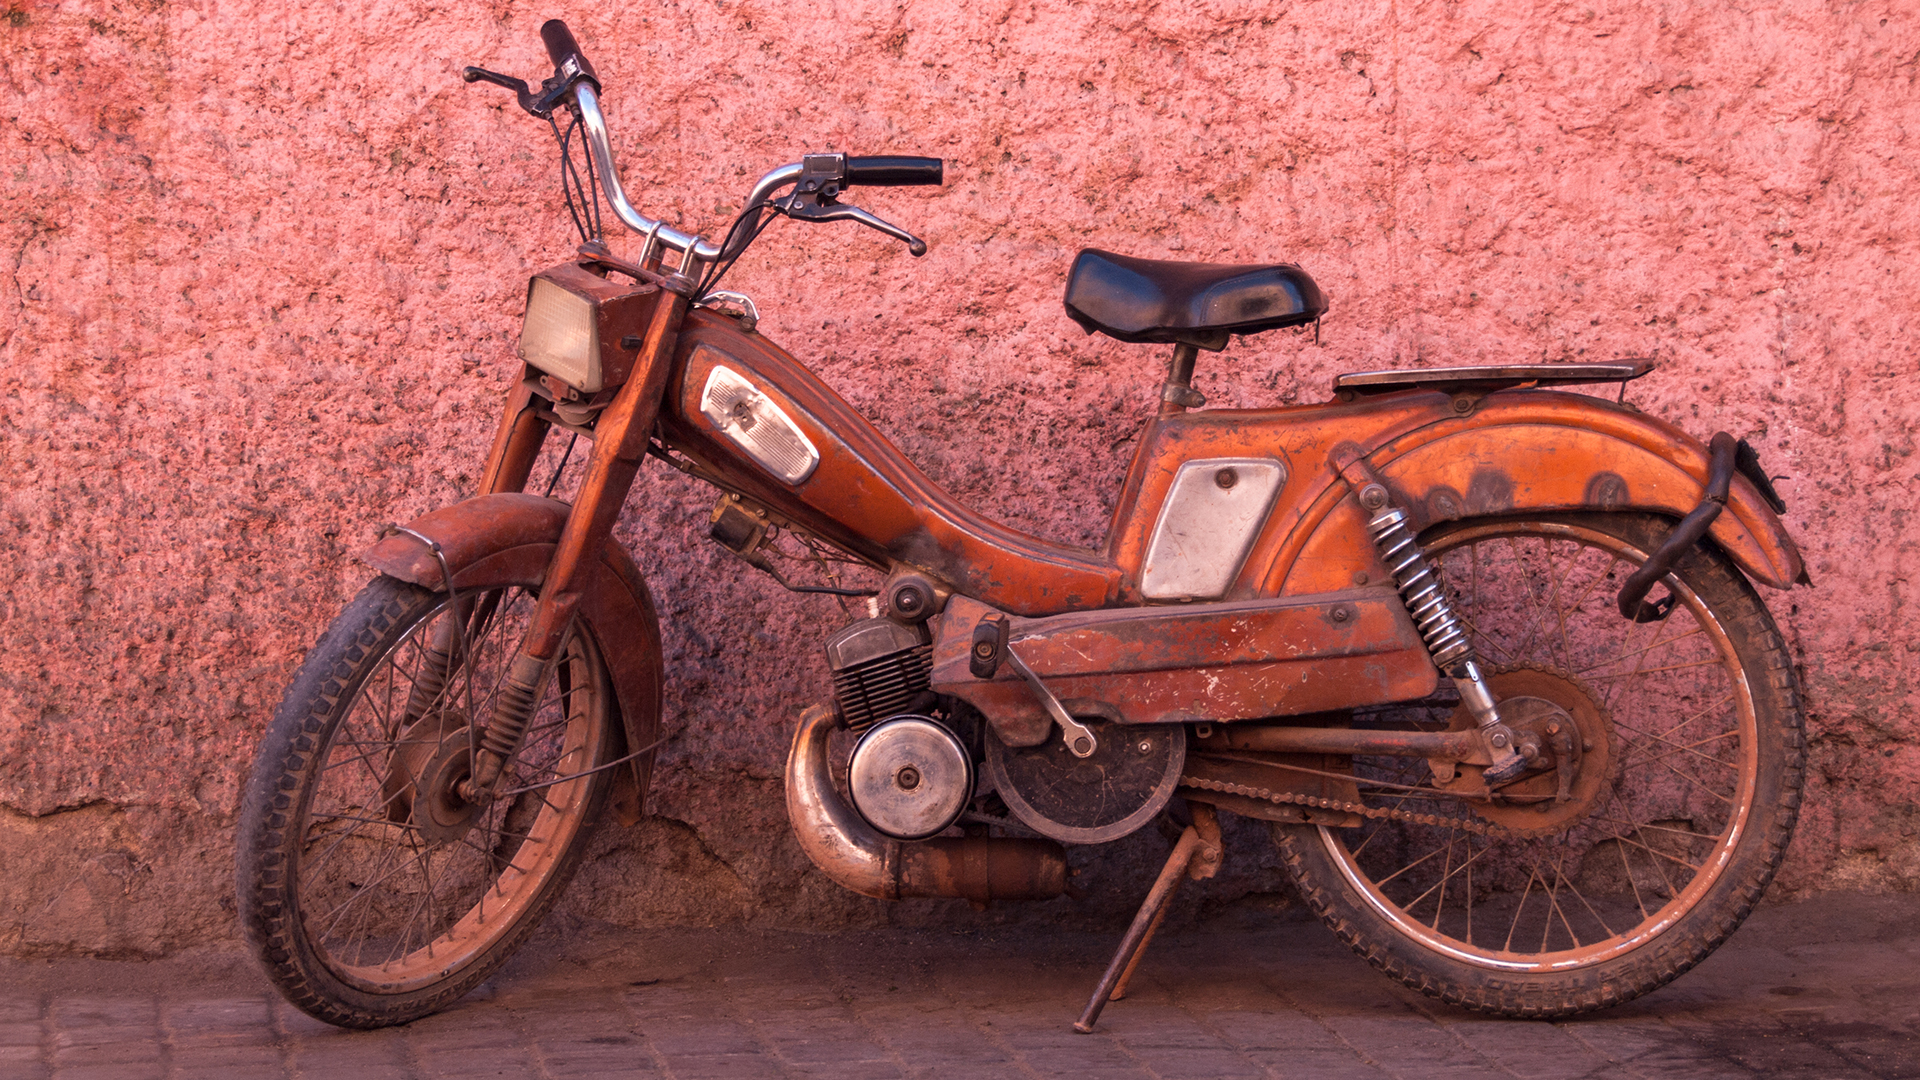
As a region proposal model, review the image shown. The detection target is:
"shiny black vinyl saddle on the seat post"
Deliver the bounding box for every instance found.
[1066,248,1327,350]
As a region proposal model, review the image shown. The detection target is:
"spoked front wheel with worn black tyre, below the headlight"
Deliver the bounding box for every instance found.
[236,577,620,1028]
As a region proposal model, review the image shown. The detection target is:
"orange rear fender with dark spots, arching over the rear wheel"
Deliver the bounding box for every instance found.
[1269,390,1807,592]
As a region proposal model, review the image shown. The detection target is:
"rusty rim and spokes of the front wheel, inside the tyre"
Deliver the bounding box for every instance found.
[290,588,609,994]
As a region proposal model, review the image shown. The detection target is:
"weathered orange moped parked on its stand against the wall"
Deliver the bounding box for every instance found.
[236,21,1811,1030]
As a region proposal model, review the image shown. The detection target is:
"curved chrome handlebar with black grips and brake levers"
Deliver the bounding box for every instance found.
[476,19,945,273]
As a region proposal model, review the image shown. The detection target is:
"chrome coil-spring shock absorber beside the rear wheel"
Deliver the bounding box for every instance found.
[1359,482,1526,784]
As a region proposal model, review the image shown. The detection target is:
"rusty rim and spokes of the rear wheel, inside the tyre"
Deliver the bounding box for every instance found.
[1319,521,1759,972]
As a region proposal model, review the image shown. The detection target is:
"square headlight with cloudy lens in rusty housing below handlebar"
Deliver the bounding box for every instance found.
[520,263,660,394]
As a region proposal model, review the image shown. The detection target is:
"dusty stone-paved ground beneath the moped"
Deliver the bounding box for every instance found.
[0,896,1920,1080]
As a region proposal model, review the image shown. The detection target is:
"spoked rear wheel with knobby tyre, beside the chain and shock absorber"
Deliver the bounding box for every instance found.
[1277,515,1805,1017]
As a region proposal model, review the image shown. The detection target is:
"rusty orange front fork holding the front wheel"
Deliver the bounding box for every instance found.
[432,290,687,801]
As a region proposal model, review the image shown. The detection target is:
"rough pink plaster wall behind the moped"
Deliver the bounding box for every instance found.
[0,0,1920,953]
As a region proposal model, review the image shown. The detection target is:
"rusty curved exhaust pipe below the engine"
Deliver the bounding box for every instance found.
[787,705,1068,903]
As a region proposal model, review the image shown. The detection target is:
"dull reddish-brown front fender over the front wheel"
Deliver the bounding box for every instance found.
[361,492,664,811]
